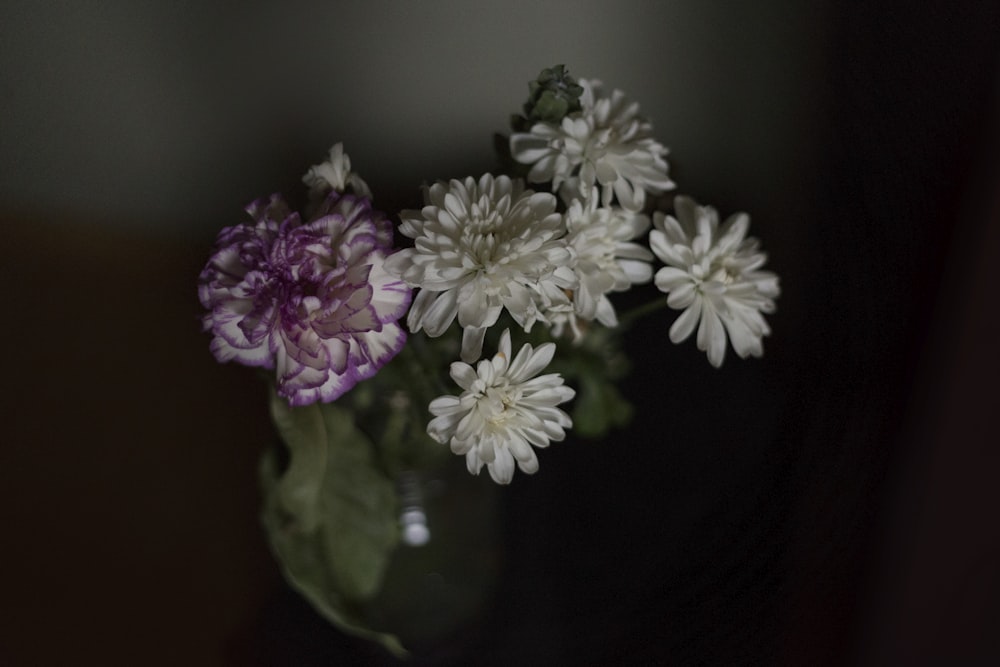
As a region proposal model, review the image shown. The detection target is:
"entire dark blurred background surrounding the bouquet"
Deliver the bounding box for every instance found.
[0,0,1000,665]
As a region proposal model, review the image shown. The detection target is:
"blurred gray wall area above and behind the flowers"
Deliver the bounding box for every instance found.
[0,0,825,237]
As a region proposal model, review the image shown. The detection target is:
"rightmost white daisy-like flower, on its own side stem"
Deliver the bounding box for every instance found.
[649,197,781,367]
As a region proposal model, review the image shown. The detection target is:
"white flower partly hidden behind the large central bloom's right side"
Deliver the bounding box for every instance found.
[565,190,653,331]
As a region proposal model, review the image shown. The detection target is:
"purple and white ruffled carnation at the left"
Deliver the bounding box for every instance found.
[198,193,410,405]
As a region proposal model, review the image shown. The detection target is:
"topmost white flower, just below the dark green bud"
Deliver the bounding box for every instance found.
[510,79,674,211]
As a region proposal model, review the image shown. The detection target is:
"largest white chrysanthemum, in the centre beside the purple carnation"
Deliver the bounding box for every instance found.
[385,174,576,363]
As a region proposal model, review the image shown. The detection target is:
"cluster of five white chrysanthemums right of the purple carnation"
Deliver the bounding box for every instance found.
[385,69,779,483]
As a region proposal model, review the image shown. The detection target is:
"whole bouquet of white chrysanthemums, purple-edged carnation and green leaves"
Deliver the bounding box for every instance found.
[199,66,779,654]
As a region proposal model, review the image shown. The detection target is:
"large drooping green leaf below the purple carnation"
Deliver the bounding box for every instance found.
[261,395,405,655]
